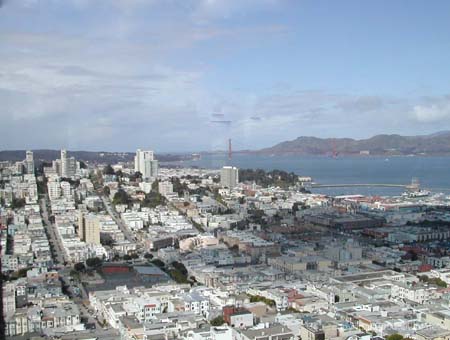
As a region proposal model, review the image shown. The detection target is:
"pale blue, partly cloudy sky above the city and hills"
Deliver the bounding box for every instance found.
[0,0,450,152]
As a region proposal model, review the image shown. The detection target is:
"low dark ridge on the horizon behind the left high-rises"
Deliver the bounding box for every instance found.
[0,150,191,164]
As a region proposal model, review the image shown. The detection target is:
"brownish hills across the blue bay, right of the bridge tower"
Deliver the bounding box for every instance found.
[256,131,450,155]
